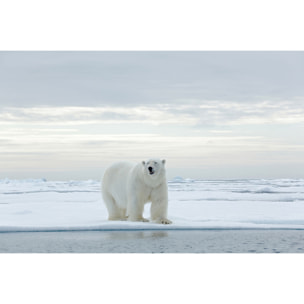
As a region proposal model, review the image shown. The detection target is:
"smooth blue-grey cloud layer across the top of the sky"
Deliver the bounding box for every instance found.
[0,52,304,107]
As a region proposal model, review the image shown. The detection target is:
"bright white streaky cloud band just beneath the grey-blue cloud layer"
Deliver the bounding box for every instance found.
[0,101,304,128]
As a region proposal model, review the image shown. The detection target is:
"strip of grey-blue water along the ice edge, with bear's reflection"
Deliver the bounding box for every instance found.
[0,230,304,253]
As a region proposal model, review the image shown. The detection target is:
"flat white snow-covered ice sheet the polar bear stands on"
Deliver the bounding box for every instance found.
[0,177,304,232]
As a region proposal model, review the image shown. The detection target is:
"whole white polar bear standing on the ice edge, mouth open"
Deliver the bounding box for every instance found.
[101,158,172,224]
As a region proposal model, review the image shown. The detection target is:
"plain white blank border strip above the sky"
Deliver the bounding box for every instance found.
[0,0,304,50]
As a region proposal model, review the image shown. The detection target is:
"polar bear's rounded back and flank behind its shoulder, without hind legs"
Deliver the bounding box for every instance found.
[102,162,136,208]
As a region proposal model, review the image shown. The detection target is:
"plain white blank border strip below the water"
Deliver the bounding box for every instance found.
[0,254,304,304]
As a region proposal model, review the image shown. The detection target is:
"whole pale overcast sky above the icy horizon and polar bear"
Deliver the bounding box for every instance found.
[0,51,304,180]
